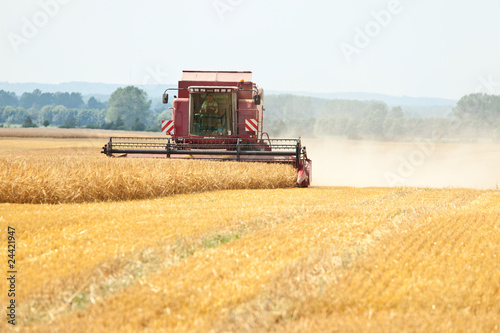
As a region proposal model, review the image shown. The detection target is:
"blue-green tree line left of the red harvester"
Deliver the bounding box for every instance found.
[0,86,171,131]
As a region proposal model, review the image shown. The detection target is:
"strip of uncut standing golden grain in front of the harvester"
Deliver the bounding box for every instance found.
[0,153,296,203]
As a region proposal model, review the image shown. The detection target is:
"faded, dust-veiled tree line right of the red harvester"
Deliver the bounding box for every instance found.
[264,93,500,141]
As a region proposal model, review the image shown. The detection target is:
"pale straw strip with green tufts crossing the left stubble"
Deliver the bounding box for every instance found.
[15,205,301,325]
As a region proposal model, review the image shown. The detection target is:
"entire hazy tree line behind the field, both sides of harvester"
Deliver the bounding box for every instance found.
[0,86,500,140]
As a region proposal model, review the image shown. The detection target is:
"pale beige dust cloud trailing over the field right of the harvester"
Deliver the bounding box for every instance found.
[302,138,500,189]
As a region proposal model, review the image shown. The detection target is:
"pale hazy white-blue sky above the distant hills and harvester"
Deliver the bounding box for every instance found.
[0,0,500,99]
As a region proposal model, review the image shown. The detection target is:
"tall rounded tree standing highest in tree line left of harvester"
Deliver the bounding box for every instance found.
[106,86,151,128]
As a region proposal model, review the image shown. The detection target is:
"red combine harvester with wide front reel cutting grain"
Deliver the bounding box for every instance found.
[102,71,312,187]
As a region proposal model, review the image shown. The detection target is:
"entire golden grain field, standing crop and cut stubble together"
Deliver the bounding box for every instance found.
[0,128,500,332]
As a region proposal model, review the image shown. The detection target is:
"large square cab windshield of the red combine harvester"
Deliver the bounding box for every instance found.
[190,93,232,136]
